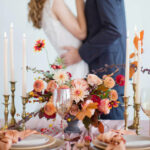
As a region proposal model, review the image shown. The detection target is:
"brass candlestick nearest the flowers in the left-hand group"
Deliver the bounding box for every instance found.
[22,97,27,130]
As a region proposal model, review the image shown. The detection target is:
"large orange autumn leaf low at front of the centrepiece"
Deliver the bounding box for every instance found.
[76,103,98,120]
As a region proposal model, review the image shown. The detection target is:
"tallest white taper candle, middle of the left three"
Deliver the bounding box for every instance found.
[10,23,15,82]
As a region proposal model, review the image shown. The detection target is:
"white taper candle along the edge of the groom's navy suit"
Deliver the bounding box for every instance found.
[124,32,130,97]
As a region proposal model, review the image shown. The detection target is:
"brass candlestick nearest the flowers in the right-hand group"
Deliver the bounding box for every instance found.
[123,97,129,130]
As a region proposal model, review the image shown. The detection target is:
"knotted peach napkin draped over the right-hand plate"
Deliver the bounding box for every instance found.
[98,130,135,150]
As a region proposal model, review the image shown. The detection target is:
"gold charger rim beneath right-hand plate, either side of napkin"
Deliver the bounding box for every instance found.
[92,140,150,150]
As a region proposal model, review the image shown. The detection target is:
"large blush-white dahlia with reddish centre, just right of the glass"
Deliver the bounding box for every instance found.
[71,85,89,103]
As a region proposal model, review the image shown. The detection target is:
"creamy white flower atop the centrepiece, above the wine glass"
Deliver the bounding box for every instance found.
[54,70,69,85]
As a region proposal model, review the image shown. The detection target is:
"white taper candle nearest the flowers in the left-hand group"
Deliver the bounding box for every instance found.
[22,34,27,97]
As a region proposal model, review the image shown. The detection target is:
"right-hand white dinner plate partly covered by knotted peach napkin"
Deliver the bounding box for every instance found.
[93,135,150,150]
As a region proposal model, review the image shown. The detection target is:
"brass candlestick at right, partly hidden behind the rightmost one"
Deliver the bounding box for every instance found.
[128,83,136,129]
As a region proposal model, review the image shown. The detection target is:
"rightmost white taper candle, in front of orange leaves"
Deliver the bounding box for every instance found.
[136,40,141,104]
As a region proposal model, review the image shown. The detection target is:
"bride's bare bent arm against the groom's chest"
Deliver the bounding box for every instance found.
[52,0,87,40]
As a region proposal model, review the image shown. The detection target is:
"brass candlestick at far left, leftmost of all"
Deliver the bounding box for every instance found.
[4,95,9,130]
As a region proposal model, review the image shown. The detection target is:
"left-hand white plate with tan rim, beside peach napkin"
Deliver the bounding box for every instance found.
[11,134,56,150]
